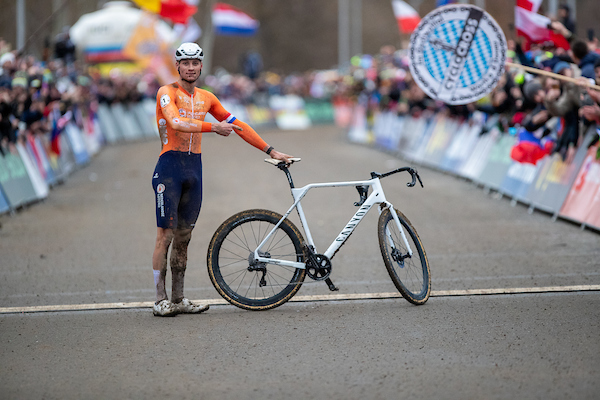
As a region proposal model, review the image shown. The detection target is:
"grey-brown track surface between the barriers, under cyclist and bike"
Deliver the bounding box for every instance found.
[0,127,600,399]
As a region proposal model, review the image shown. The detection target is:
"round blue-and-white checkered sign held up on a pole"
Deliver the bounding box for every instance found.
[409,4,506,105]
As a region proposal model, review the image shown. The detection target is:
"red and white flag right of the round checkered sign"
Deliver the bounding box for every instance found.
[515,0,569,50]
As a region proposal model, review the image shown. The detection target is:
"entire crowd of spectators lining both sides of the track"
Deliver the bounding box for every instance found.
[0,10,600,166]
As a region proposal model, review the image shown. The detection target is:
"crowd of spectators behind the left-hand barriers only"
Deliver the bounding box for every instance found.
[0,37,158,154]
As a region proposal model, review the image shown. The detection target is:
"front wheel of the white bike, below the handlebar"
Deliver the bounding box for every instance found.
[377,209,431,305]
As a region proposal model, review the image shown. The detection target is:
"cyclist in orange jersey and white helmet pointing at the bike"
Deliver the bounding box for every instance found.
[152,43,292,316]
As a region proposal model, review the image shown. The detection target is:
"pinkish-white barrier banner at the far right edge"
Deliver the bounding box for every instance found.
[560,146,600,229]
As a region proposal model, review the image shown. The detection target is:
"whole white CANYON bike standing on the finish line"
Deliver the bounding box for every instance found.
[207,158,431,310]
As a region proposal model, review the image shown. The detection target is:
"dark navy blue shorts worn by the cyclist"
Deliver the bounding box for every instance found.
[152,151,202,229]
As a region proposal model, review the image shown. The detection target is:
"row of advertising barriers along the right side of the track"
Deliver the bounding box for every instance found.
[348,104,600,233]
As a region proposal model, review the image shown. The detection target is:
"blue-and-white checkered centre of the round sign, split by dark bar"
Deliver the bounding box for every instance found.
[423,19,492,87]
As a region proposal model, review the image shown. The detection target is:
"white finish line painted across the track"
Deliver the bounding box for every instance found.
[0,285,600,314]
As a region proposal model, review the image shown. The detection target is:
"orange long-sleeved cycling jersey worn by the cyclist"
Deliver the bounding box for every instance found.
[156,82,267,155]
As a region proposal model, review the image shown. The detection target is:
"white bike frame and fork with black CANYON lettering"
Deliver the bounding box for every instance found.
[254,177,412,269]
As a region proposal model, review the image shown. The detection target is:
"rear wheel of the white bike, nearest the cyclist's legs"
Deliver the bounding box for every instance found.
[207,210,306,310]
